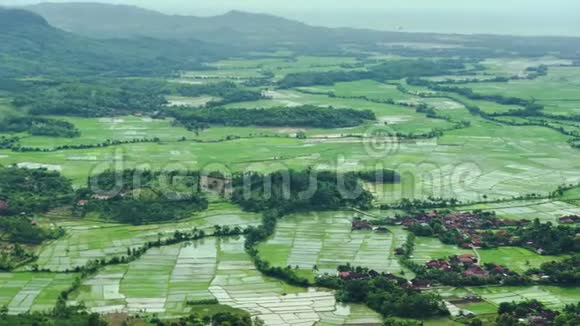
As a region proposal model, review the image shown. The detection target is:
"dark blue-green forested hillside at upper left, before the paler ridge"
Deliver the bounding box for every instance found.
[0,8,230,79]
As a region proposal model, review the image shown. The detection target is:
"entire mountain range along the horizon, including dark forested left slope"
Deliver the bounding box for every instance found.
[0,3,580,78]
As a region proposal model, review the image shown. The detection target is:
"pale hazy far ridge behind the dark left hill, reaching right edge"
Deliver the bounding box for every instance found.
[23,3,580,56]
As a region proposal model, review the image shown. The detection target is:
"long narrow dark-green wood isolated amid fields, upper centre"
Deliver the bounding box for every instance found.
[170,105,376,130]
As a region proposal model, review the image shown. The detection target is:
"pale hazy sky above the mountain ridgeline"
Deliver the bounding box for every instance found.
[0,0,580,36]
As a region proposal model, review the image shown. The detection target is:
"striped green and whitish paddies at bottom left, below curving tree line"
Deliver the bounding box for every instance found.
[72,238,377,325]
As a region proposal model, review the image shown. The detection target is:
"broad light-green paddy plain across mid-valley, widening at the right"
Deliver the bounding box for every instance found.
[0,116,580,201]
